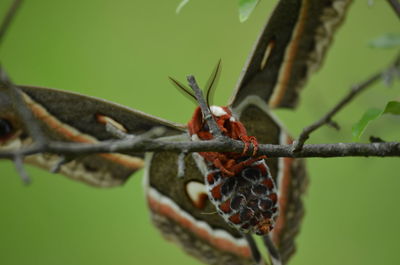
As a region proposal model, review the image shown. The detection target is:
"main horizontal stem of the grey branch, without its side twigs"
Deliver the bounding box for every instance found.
[0,139,400,159]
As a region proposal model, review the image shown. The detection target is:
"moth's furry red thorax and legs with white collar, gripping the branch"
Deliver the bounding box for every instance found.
[188,106,266,176]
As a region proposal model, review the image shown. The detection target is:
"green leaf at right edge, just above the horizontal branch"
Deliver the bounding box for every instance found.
[352,101,400,140]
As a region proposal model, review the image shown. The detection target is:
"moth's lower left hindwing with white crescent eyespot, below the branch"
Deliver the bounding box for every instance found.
[144,136,260,265]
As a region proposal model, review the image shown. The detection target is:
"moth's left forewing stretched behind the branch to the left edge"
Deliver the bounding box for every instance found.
[0,86,184,187]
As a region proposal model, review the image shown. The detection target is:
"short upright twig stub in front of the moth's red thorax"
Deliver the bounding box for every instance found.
[187,75,224,139]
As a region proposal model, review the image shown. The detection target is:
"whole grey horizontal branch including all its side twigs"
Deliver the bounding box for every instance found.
[0,62,400,182]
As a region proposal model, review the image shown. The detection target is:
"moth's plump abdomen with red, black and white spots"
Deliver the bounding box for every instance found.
[206,159,278,235]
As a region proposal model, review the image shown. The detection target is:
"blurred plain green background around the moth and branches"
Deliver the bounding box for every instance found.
[0,0,400,265]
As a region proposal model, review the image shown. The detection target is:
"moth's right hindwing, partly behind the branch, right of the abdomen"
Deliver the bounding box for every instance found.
[233,96,308,264]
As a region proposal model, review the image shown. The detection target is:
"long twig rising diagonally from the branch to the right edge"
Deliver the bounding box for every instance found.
[293,56,400,152]
